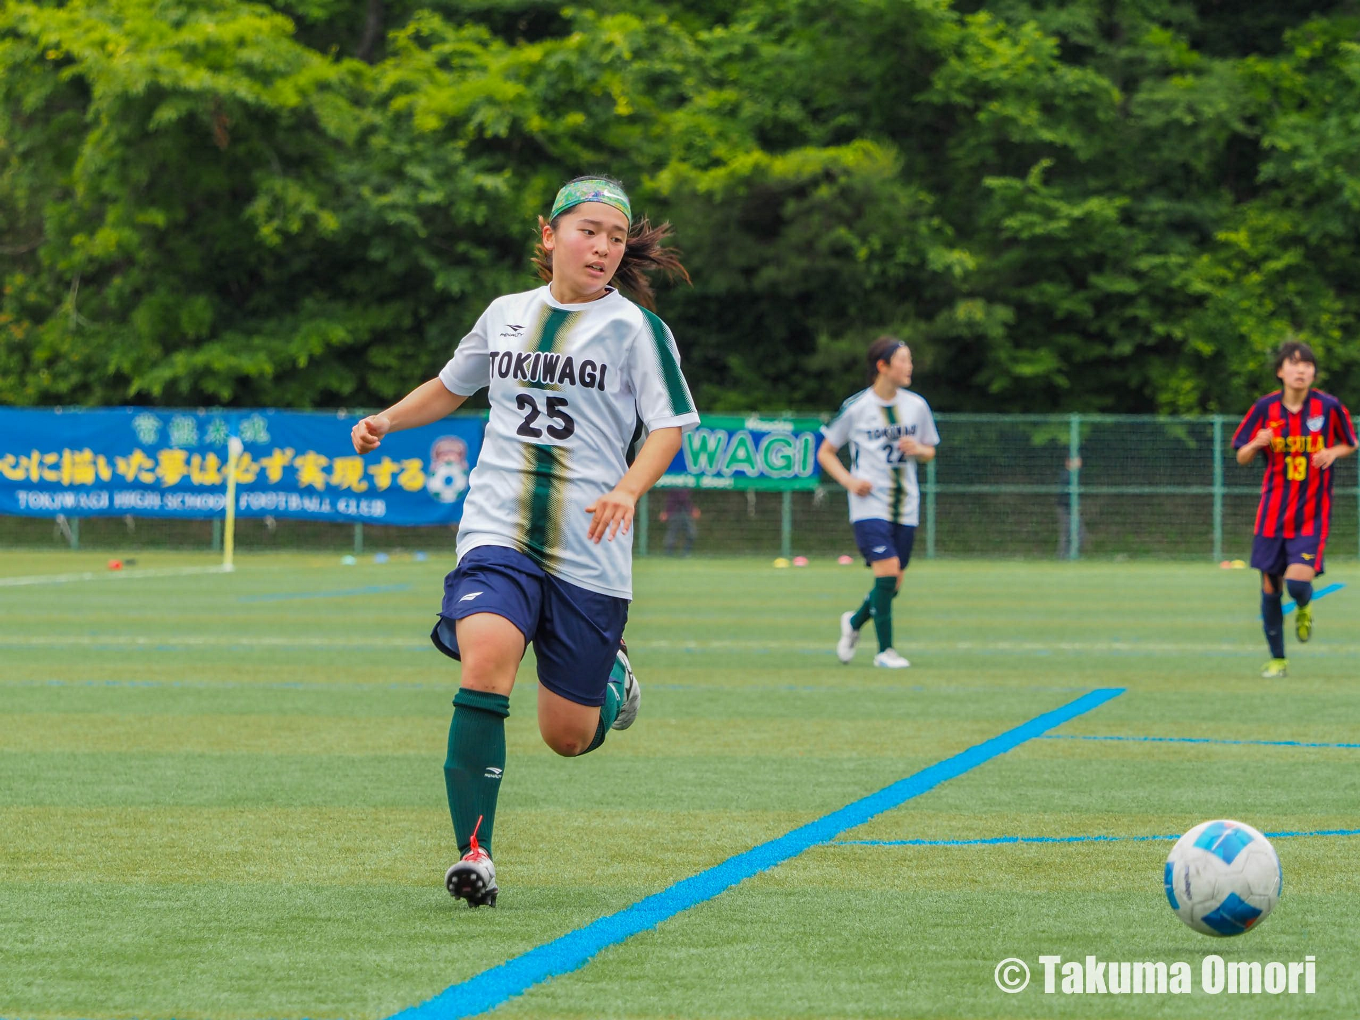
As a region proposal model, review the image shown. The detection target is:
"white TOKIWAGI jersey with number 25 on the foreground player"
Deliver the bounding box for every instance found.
[439,287,699,598]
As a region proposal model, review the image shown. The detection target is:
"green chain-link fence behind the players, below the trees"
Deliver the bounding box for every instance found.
[0,415,1360,560]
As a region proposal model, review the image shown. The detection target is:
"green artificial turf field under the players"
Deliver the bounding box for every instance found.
[0,551,1360,1020]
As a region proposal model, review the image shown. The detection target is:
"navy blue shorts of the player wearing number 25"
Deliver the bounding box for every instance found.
[430,545,628,706]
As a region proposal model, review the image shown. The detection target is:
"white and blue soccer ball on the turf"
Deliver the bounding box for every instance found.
[1164,819,1284,936]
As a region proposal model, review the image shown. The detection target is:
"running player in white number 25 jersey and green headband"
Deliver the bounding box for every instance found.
[352,177,699,907]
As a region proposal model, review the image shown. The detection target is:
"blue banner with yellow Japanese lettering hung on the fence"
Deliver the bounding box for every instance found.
[0,407,486,525]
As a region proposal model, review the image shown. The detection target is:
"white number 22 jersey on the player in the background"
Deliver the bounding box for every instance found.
[821,386,940,525]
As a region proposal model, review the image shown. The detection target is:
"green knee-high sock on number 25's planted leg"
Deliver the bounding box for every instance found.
[443,687,510,854]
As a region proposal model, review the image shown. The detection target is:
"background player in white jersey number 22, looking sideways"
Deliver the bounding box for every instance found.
[817,336,940,669]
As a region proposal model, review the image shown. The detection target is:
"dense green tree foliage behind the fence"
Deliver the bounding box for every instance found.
[0,0,1360,412]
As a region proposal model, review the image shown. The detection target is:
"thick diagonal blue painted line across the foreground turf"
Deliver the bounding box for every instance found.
[389,688,1123,1020]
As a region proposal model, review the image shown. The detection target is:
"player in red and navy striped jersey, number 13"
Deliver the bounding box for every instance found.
[1232,341,1357,677]
